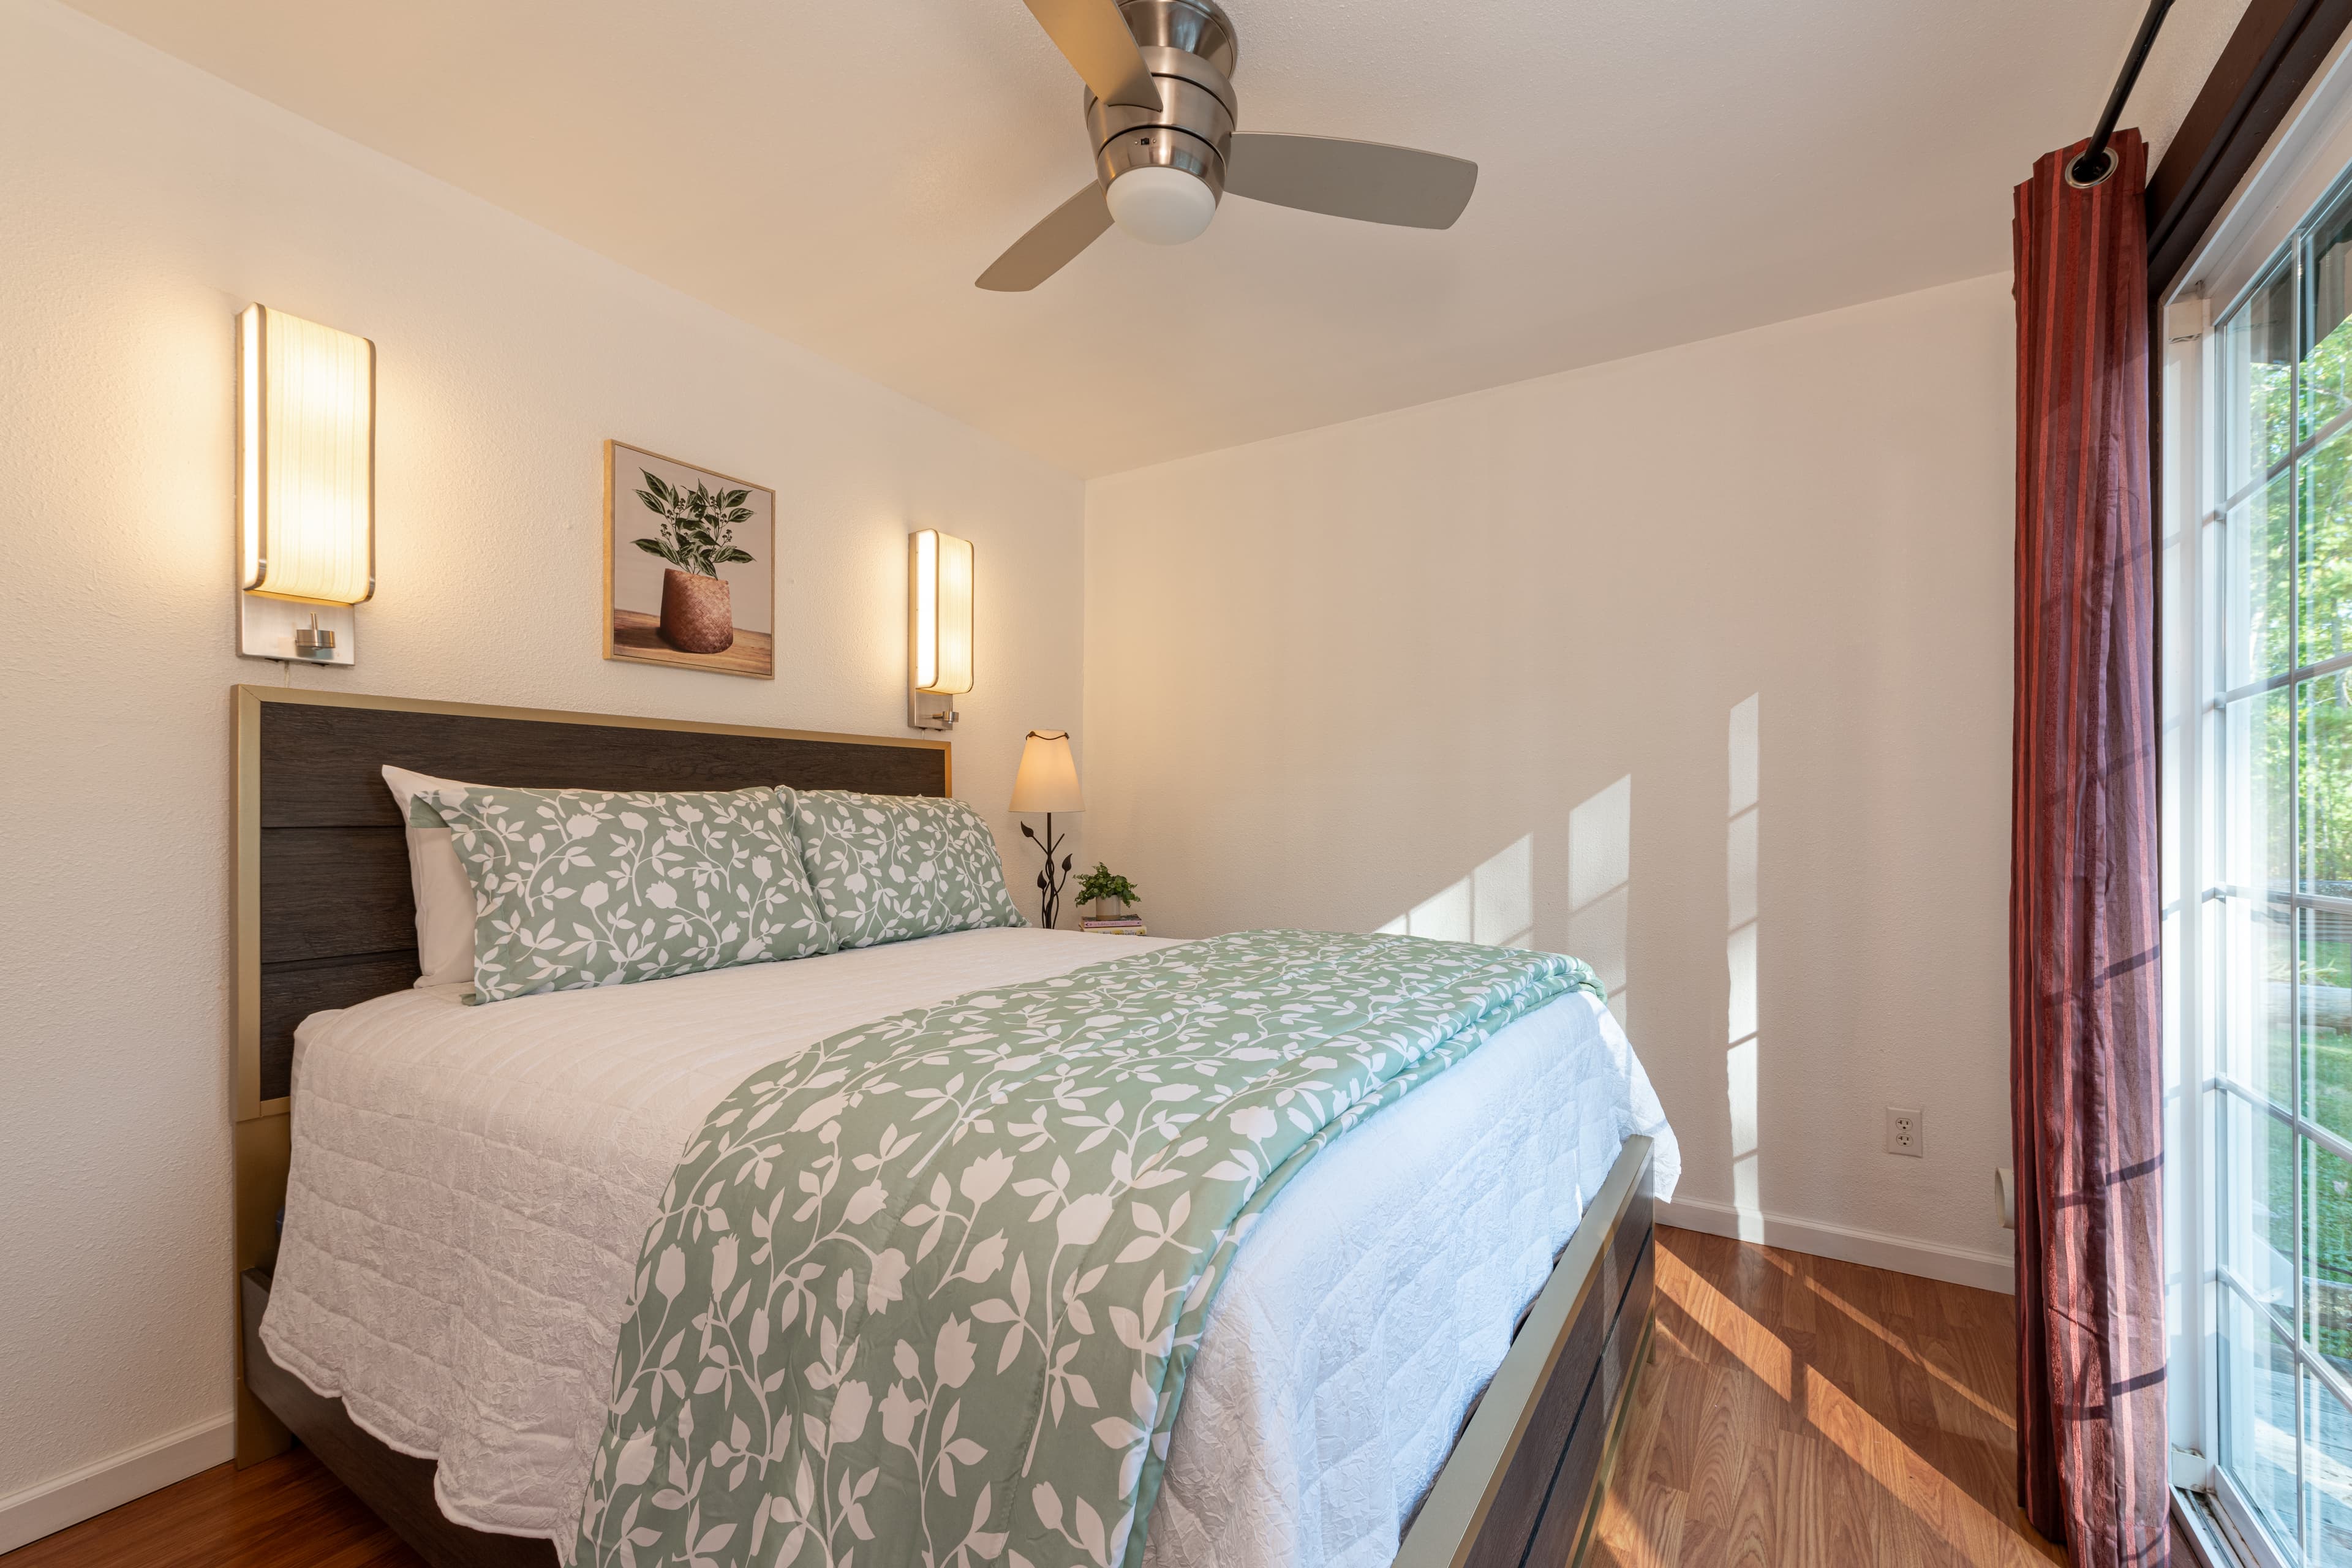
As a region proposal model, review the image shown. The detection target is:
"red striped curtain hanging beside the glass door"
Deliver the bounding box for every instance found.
[2008,132,2171,1568]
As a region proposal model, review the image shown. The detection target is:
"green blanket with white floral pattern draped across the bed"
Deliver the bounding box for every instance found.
[574,931,1602,1568]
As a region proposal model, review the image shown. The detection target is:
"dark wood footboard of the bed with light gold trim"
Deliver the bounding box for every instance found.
[1395,1138,1656,1568]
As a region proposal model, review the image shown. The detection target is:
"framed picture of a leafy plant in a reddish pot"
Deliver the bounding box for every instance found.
[605,442,776,679]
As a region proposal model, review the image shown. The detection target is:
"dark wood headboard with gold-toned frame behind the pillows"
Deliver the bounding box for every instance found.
[233,687,952,1458]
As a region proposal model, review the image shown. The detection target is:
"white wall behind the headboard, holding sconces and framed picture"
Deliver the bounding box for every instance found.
[0,0,1084,1547]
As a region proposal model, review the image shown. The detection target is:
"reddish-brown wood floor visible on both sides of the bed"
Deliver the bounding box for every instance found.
[13,1227,2079,1568]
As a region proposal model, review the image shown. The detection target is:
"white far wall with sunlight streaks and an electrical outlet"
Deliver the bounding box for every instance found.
[1087,277,2013,1286]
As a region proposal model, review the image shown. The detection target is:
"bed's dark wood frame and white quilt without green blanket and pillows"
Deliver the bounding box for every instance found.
[224,689,1677,1568]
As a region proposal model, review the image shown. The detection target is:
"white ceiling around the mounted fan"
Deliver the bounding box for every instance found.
[78,0,2244,475]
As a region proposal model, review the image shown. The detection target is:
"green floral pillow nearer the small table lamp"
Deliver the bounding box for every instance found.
[778,790,1028,948]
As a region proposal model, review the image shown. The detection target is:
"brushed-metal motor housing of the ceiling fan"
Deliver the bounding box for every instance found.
[1087,0,1240,200]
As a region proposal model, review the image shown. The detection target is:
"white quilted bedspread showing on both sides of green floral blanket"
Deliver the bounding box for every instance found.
[261,931,1679,1568]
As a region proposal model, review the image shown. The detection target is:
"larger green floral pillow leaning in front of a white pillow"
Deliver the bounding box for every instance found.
[417,785,835,1001]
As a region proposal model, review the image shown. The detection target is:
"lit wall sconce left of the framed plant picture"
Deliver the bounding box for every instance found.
[238,306,376,665]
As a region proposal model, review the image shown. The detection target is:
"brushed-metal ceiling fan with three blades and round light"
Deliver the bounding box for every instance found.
[978,0,1477,294]
